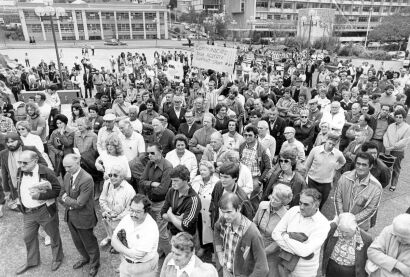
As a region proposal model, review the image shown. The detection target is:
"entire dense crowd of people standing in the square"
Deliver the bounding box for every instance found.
[0,45,410,277]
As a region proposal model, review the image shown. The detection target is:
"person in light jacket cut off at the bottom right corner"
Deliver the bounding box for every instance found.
[366,214,410,277]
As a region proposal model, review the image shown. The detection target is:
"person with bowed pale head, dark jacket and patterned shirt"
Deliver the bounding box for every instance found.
[322,213,372,277]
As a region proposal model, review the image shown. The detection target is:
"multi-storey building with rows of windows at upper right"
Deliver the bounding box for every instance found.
[225,0,410,41]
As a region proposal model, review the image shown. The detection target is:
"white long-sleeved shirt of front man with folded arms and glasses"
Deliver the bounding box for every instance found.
[272,206,330,277]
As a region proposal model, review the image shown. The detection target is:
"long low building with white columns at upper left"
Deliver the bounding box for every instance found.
[17,2,169,41]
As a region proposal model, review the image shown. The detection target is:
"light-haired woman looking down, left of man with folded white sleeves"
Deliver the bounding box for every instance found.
[253,184,293,277]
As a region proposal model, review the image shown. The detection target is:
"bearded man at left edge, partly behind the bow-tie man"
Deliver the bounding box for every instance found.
[0,132,47,217]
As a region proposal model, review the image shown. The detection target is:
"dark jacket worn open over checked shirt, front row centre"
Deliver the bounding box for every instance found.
[214,217,269,277]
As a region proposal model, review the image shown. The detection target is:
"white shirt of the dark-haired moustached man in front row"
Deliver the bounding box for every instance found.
[113,214,159,263]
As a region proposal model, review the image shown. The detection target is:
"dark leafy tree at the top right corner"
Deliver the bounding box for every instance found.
[369,9,410,42]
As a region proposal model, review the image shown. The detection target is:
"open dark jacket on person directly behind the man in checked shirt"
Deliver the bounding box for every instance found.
[209,181,256,229]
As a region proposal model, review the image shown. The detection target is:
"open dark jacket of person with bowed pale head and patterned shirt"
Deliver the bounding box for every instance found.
[322,223,373,277]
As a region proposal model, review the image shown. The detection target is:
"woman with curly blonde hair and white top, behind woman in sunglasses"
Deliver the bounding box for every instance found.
[95,134,131,179]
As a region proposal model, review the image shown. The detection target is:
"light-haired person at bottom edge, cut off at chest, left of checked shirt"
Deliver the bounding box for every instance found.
[160,232,218,277]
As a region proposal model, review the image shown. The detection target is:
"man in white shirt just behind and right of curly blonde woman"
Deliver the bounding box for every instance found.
[118,118,145,161]
